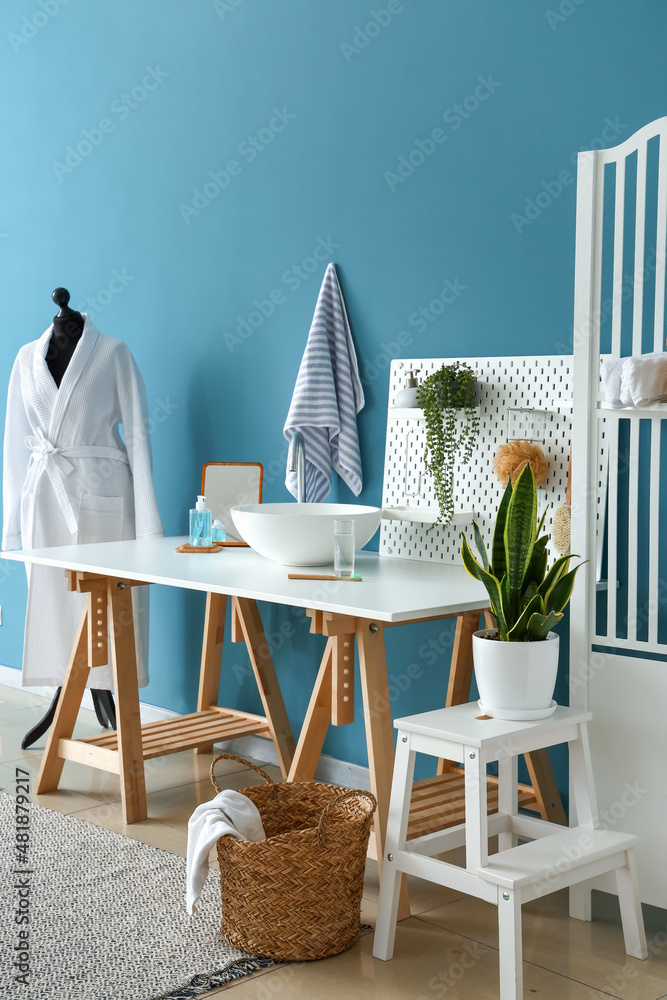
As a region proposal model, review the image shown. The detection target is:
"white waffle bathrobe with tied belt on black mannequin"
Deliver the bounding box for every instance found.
[2,313,163,689]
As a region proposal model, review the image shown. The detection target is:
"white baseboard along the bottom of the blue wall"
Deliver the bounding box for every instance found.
[0,664,371,791]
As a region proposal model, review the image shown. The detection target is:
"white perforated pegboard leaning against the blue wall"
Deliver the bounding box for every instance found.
[380,355,572,563]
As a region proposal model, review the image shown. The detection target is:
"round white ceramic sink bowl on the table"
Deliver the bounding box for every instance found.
[231,502,382,566]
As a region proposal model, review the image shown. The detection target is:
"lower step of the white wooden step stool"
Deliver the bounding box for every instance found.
[477,826,638,891]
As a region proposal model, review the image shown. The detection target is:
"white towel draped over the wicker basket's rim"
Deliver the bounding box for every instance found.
[185,788,266,913]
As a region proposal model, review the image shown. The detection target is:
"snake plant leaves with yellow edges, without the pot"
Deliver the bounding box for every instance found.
[461,465,581,642]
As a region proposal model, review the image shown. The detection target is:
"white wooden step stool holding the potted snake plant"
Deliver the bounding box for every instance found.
[373,702,648,1000]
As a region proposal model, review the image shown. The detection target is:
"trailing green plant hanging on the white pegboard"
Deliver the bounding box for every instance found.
[417,361,479,530]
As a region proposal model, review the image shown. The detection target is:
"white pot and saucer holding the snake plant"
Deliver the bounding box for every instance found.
[472,629,558,722]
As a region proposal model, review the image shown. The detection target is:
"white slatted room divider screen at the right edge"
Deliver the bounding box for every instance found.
[570,118,667,907]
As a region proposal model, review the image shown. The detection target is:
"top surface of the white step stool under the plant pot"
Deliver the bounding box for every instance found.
[394,701,593,748]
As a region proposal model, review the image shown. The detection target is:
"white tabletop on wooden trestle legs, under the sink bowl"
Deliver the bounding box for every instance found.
[2,537,488,622]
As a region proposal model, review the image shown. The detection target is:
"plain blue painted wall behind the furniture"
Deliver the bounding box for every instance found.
[0,0,667,788]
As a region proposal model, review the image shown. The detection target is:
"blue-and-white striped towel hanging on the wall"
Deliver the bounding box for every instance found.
[283,264,364,503]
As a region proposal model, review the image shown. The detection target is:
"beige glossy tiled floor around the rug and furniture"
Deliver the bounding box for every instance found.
[0,687,667,1000]
